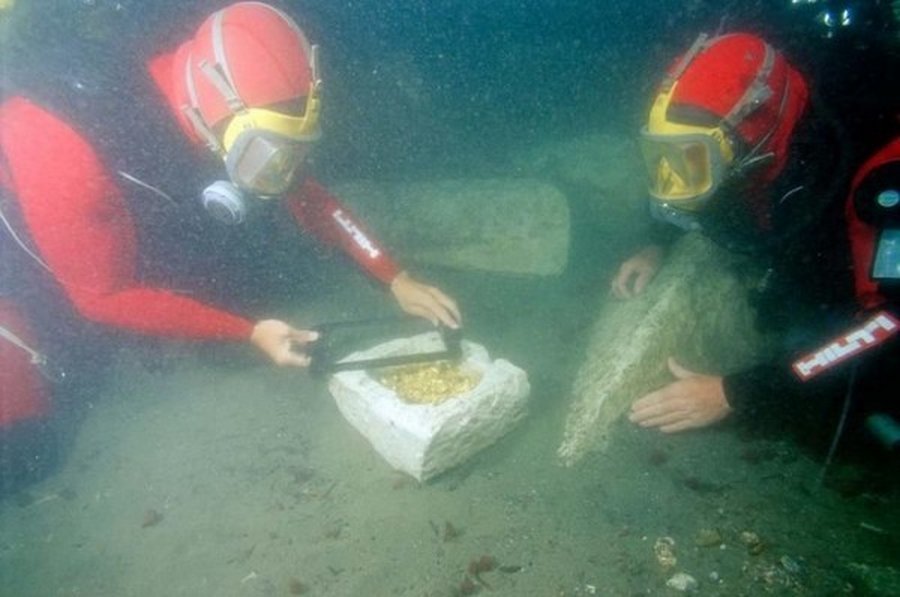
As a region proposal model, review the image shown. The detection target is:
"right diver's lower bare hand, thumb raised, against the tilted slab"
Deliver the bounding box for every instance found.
[628,357,731,433]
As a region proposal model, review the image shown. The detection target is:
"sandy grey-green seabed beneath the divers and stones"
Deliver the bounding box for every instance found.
[0,262,900,597]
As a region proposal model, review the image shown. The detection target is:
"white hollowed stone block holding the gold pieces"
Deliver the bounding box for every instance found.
[329,332,530,481]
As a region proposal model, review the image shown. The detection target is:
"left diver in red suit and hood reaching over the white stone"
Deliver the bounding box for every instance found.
[0,2,461,486]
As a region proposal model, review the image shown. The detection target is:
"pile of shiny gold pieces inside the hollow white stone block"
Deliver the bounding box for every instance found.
[375,361,481,404]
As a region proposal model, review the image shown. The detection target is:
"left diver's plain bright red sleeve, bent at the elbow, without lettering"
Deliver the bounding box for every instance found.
[0,97,253,340]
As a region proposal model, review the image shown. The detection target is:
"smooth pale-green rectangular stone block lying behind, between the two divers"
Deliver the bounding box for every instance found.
[334,179,569,276]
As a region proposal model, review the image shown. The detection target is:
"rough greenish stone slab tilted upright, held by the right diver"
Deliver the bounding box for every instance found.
[558,234,769,465]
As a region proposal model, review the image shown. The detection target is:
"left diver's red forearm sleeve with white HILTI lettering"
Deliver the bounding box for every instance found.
[287,177,400,284]
